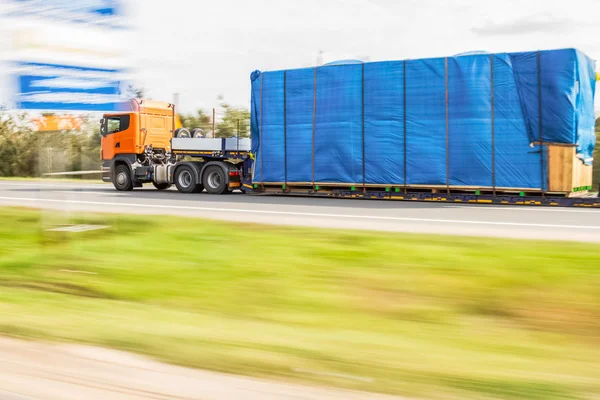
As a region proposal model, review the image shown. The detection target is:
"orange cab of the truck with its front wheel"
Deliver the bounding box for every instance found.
[100,99,181,190]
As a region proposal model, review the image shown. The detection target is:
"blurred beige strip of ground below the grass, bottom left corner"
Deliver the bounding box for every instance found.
[0,338,406,400]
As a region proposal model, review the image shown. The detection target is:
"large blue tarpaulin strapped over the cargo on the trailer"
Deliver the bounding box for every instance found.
[251,49,596,190]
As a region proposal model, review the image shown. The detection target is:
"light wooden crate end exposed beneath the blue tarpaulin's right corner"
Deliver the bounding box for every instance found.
[548,144,592,194]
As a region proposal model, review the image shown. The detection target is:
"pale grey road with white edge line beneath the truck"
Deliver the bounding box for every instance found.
[0,181,600,242]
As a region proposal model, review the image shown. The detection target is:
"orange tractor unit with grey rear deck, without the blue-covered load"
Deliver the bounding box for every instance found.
[100,99,251,194]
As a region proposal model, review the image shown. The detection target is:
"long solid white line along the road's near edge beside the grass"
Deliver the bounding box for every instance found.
[0,197,600,230]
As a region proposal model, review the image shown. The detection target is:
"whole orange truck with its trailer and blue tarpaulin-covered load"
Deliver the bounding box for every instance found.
[101,49,600,207]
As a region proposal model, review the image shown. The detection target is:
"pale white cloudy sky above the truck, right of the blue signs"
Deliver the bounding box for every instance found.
[129,0,600,112]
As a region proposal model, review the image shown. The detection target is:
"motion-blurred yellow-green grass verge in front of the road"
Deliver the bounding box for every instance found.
[0,208,600,400]
